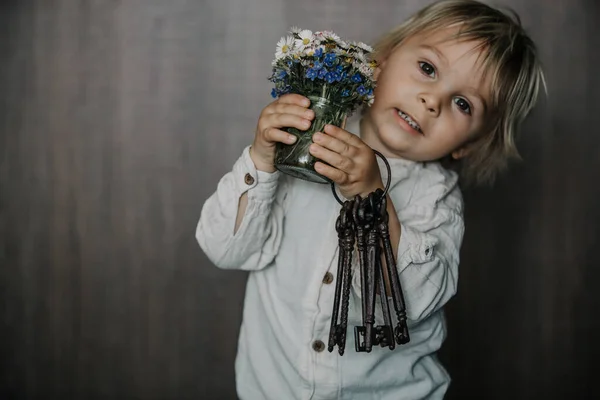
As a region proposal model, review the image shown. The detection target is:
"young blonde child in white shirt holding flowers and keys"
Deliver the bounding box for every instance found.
[196,0,544,400]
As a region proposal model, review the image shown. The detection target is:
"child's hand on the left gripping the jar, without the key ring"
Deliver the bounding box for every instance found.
[250,94,315,172]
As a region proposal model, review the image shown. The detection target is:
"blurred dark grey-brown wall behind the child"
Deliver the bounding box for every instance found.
[0,0,600,399]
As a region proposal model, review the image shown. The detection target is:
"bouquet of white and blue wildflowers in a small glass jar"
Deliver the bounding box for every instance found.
[269,28,376,183]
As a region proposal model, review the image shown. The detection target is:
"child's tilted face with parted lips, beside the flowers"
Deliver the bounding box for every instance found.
[361,28,490,161]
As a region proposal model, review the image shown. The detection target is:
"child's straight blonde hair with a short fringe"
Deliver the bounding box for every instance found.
[373,0,546,184]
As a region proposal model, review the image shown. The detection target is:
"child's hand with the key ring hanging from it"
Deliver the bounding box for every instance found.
[310,125,384,199]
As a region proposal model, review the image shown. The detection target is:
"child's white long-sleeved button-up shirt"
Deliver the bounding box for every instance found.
[196,119,464,400]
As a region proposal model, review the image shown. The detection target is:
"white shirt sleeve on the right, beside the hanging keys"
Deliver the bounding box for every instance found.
[353,175,464,325]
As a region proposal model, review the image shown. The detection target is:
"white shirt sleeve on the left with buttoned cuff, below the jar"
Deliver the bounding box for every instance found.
[196,147,284,270]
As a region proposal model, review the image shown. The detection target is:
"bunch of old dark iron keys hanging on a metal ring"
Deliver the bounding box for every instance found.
[328,150,410,355]
